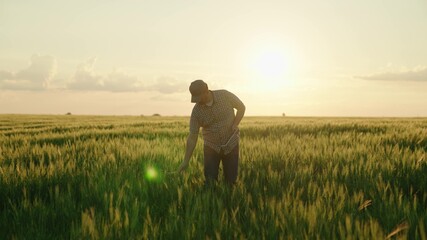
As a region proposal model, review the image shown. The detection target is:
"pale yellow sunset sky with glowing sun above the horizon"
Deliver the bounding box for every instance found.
[0,0,427,117]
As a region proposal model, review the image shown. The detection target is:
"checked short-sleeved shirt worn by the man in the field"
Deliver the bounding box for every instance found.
[190,90,245,154]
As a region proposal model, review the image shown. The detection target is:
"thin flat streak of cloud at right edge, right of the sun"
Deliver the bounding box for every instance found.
[355,67,427,82]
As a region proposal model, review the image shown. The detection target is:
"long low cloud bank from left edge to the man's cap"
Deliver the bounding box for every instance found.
[0,55,188,94]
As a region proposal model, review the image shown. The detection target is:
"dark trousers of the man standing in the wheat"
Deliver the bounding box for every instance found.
[203,145,239,184]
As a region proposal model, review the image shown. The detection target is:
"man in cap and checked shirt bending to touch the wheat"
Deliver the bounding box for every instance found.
[178,80,246,184]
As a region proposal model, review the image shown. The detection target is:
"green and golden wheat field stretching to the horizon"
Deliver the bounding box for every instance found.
[0,115,427,239]
